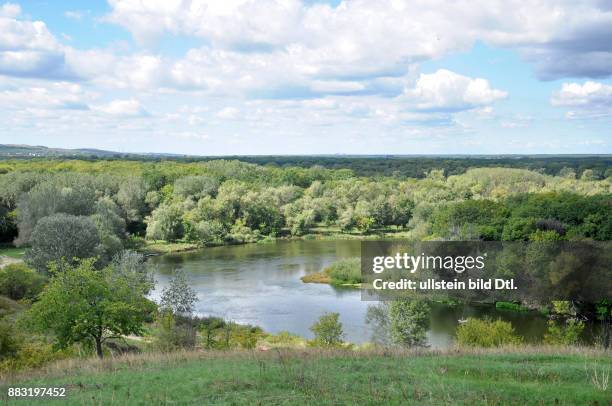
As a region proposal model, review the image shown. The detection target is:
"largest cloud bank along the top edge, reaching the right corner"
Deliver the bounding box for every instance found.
[107,0,612,79]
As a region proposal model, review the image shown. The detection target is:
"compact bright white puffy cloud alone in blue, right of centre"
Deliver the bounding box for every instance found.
[401,69,508,111]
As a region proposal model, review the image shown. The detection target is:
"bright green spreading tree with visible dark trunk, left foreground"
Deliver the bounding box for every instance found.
[28,259,155,358]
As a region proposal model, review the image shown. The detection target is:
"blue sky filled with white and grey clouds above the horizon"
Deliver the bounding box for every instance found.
[0,0,612,155]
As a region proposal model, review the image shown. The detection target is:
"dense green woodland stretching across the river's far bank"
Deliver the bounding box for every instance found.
[0,156,612,270]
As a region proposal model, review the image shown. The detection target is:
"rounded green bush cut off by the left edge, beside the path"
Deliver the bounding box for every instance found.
[0,264,46,300]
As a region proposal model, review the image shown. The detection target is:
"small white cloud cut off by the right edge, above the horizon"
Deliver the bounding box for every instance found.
[550,81,612,118]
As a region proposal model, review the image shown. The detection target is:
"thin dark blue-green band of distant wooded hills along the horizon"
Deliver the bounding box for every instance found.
[0,144,612,179]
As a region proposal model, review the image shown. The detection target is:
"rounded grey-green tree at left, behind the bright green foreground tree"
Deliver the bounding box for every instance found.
[25,214,100,271]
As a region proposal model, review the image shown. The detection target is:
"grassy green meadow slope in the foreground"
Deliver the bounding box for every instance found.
[0,347,612,405]
